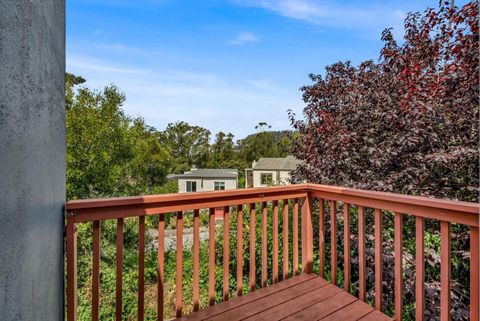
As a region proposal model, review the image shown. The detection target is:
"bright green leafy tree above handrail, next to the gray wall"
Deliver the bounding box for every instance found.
[65,74,172,199]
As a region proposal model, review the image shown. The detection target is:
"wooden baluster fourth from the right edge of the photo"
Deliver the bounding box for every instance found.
[394,213,403,320]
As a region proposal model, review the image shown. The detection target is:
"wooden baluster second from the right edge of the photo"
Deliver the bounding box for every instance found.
[440,221,452,321]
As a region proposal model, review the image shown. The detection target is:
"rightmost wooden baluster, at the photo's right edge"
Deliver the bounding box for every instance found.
[470,226,480,320]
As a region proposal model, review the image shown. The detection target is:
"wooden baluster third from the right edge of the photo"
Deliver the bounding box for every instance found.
[415,216,425,321]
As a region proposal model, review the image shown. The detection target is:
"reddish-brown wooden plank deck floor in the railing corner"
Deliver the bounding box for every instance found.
[176,274,392,321]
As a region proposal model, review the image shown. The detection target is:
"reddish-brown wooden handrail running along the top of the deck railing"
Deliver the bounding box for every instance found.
[66,183,480,227]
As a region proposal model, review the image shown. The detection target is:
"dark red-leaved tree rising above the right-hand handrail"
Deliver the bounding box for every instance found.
[290,1,480,201]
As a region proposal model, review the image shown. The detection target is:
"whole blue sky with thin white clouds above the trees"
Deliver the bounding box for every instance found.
[67,0,456,139]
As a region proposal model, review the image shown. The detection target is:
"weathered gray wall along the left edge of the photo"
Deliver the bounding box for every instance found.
[0,0,65,321]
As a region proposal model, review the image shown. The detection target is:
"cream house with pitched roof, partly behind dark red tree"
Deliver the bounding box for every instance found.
[245,156,300,188]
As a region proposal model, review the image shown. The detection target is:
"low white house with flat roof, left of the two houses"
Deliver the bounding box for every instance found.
[168,168,238,193]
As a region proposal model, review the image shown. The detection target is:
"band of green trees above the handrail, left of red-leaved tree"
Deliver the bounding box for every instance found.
[66,74,292,199]
